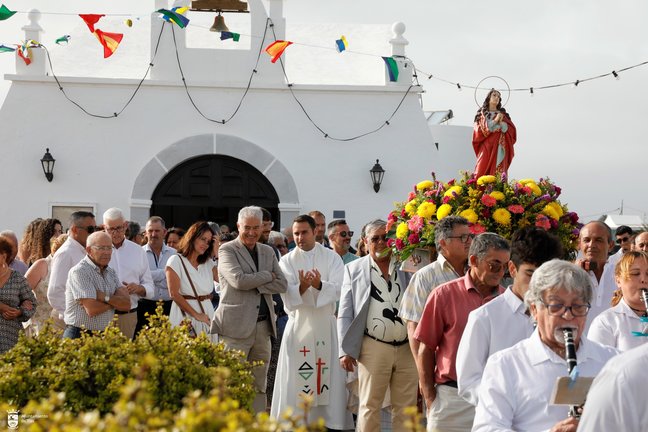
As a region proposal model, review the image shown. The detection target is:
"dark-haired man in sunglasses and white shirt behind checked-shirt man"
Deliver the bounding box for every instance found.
[47,211,97,330]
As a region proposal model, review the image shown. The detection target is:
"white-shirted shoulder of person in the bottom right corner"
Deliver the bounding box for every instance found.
[578,344,648,432]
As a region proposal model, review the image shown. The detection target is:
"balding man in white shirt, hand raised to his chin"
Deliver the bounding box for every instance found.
[576,221,617,334]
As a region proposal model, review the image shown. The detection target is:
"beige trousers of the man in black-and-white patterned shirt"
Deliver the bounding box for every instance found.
[357,336,418,432]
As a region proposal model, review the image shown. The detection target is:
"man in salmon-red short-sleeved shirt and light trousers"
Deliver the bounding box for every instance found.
[414,233,511,432]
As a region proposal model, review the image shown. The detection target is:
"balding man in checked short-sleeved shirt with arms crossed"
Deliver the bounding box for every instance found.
[63,232,130,339]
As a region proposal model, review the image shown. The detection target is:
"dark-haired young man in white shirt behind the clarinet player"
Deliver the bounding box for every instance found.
[457,227,562,405]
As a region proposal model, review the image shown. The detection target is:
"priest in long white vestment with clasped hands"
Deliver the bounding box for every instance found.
[270,215,354,430]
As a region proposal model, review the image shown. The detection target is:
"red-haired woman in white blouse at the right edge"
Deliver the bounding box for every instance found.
[588,251,648,351]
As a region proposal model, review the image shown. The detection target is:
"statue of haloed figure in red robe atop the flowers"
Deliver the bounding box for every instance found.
[473,89,517,178]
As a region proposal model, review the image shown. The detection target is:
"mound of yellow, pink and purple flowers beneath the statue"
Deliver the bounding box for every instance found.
[387,173,582,260]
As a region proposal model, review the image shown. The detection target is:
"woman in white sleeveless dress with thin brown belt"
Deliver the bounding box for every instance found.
[166,222,218,342]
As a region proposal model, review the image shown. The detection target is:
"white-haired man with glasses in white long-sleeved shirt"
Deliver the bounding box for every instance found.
[103,207,155,339]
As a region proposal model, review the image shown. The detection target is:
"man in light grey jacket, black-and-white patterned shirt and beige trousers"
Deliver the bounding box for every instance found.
[338,220,418,431]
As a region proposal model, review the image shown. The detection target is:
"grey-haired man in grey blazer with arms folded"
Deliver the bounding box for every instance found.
[212,206,287,412]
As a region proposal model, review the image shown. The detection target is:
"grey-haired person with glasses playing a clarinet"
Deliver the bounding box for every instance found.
[473,259,623,432]
